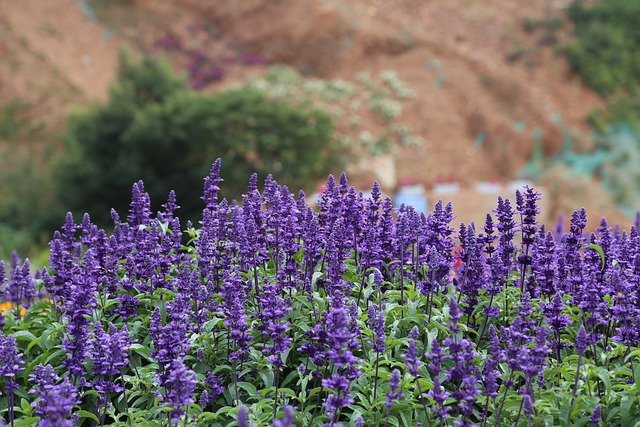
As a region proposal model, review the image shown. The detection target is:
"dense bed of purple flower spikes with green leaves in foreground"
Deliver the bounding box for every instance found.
[0,160,640,427]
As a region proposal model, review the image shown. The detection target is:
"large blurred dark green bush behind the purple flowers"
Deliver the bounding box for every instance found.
[55,56,340,225]
